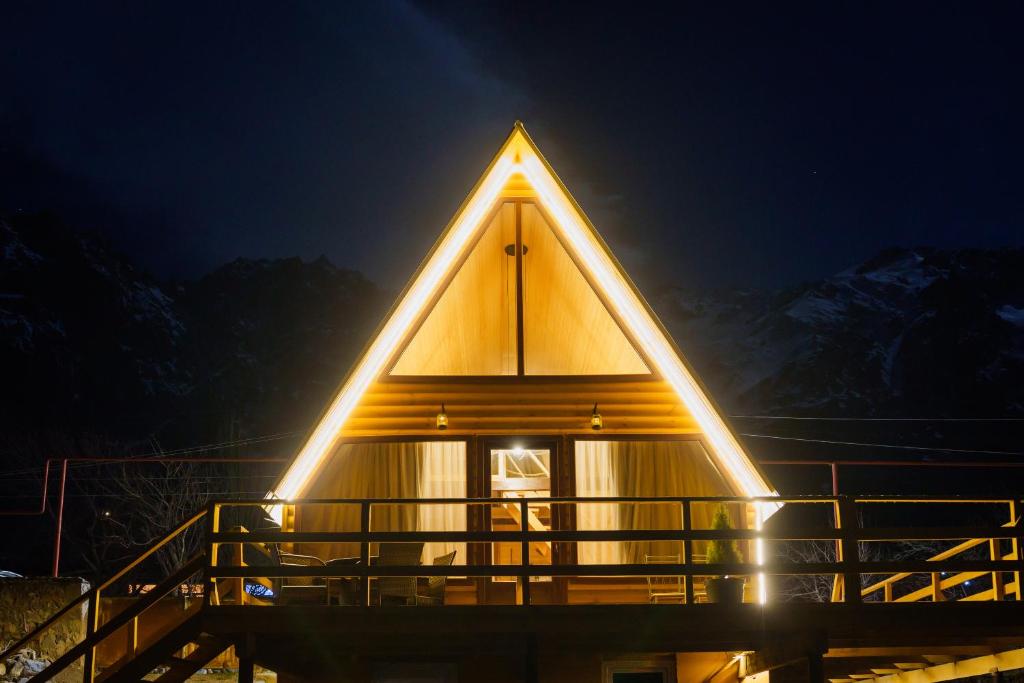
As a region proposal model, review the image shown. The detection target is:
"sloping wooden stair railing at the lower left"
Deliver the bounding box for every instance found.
[0,510,207,683]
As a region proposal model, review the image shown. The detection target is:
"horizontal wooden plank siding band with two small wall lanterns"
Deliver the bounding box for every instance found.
[344,377,699,436]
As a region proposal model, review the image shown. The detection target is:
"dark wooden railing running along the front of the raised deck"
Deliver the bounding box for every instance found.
[201,497,1024,605]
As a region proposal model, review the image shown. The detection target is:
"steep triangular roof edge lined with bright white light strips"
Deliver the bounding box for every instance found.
[271,122,773,500]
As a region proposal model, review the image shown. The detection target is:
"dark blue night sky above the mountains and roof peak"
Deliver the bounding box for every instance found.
[0,2,1024,287]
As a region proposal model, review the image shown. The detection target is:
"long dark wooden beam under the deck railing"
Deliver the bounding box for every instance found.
[204,603,1024,661]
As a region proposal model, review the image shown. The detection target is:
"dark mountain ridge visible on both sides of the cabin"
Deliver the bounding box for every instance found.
[0,214,1024,458]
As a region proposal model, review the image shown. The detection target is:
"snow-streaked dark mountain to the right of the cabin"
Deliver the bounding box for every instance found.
[654,249,1024,417]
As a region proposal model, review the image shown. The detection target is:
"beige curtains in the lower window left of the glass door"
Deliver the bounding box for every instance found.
[295,441,466,563]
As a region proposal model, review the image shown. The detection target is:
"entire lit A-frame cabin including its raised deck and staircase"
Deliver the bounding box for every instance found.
[8,123,1024,683]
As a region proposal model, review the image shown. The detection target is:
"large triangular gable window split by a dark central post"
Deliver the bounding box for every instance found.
[390,201,649,376]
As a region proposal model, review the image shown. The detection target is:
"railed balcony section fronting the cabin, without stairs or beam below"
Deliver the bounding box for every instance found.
[206,497,1022,608]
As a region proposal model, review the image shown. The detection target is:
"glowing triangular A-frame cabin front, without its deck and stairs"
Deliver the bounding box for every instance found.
[271,122,773,596]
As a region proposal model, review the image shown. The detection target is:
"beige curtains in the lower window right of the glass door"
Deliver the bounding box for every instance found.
[575,441,734,564]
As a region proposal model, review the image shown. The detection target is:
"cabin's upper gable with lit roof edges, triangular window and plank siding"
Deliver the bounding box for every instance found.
[272,123,773,499]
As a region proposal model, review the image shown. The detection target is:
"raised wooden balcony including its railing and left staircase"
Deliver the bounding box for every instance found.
[9,497,1024,683]
